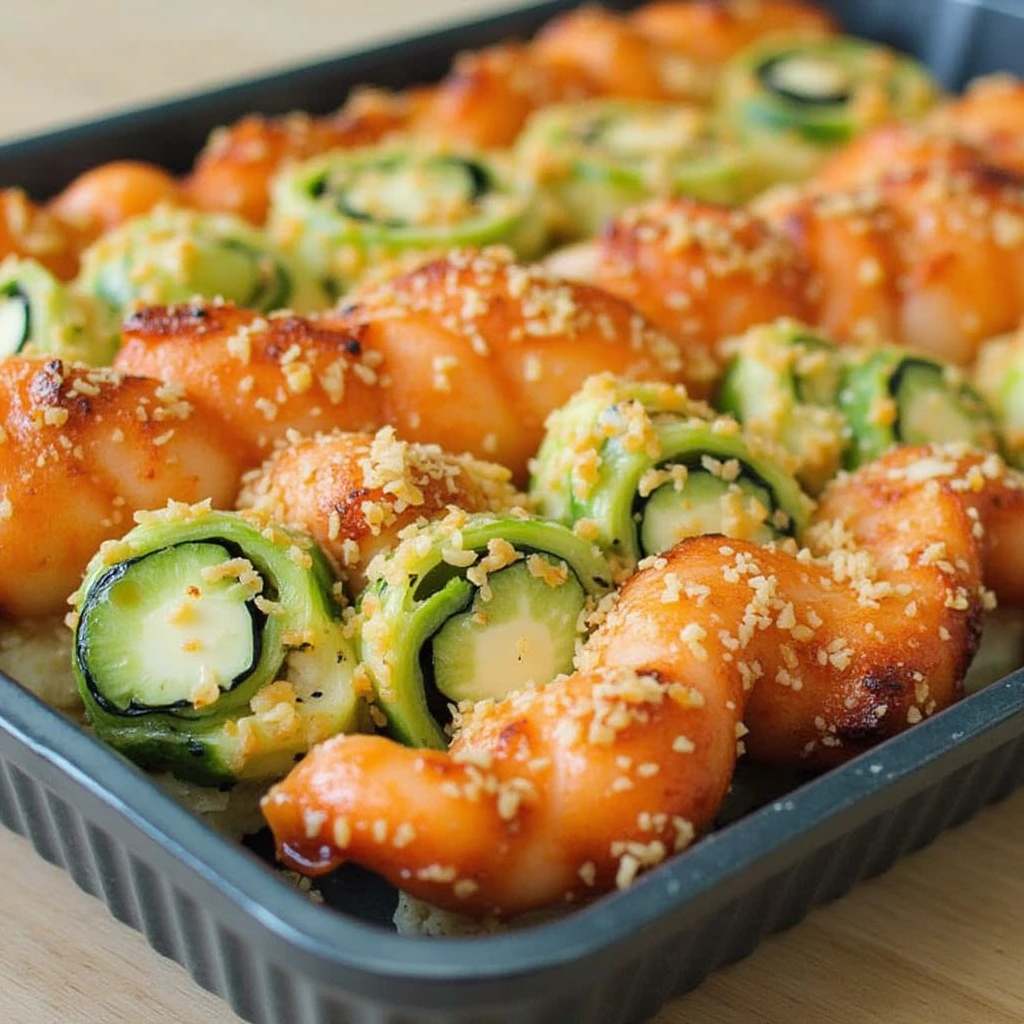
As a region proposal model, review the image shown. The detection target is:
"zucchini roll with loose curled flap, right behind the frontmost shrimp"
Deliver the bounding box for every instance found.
[359,510,611,748]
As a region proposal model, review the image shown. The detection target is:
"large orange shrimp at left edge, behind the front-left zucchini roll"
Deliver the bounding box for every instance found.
[0,356,242,617]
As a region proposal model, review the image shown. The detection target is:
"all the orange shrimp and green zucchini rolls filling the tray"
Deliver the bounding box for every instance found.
[0,0,1024,918]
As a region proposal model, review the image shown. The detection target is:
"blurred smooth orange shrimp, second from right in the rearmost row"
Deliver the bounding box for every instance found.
[532,7,712,100]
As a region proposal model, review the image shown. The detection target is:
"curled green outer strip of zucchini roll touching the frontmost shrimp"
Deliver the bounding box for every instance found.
[359,512,611,749]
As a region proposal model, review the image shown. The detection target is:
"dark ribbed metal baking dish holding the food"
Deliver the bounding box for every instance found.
[0,0,1024,1024]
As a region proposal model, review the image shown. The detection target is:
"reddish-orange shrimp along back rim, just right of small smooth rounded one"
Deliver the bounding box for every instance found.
[184,100,407,224]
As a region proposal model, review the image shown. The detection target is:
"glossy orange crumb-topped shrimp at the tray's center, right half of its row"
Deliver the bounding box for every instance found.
[341,249,707,480]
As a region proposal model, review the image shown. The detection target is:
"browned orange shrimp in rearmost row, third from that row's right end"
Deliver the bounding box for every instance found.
[411,44,594,148]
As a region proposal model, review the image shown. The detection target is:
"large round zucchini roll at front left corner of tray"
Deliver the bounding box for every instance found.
[73,504,360,784]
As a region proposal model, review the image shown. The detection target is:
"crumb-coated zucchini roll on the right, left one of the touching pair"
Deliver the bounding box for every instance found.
[717,321,846,494]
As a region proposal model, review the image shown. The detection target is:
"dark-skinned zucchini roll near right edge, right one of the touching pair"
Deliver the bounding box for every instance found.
[839,348,998,468]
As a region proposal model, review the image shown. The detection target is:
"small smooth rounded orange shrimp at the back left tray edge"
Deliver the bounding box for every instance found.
[50,160,181,242]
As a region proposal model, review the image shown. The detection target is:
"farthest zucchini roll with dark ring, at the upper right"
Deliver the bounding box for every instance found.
[718,36,938,183]
